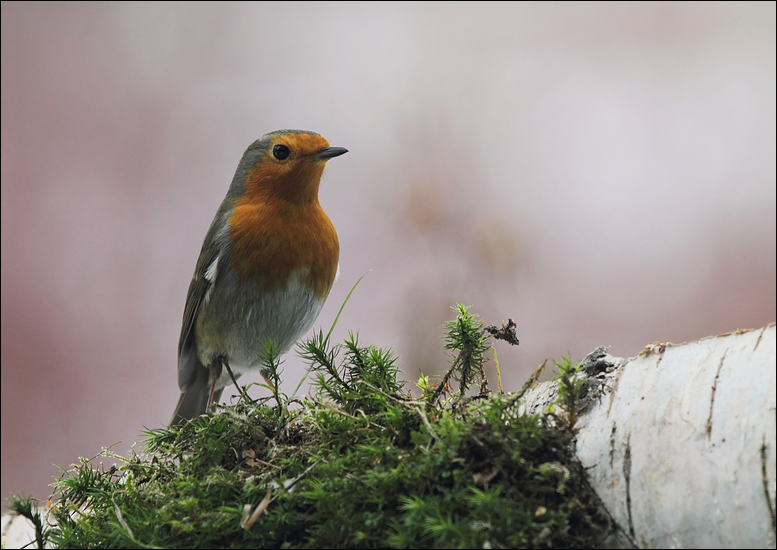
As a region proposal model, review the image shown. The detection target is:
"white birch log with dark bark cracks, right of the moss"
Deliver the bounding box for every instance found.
[523,324,777,548]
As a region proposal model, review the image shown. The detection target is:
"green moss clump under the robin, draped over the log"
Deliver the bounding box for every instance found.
[36,305,609,548]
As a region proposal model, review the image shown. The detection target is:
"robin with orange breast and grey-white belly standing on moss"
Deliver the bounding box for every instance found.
[170,130,348,425]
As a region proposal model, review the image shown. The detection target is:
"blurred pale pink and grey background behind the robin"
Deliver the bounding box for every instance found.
[0,2,776,506]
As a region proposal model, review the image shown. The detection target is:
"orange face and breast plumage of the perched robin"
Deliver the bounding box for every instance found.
[229,134,340,298]
